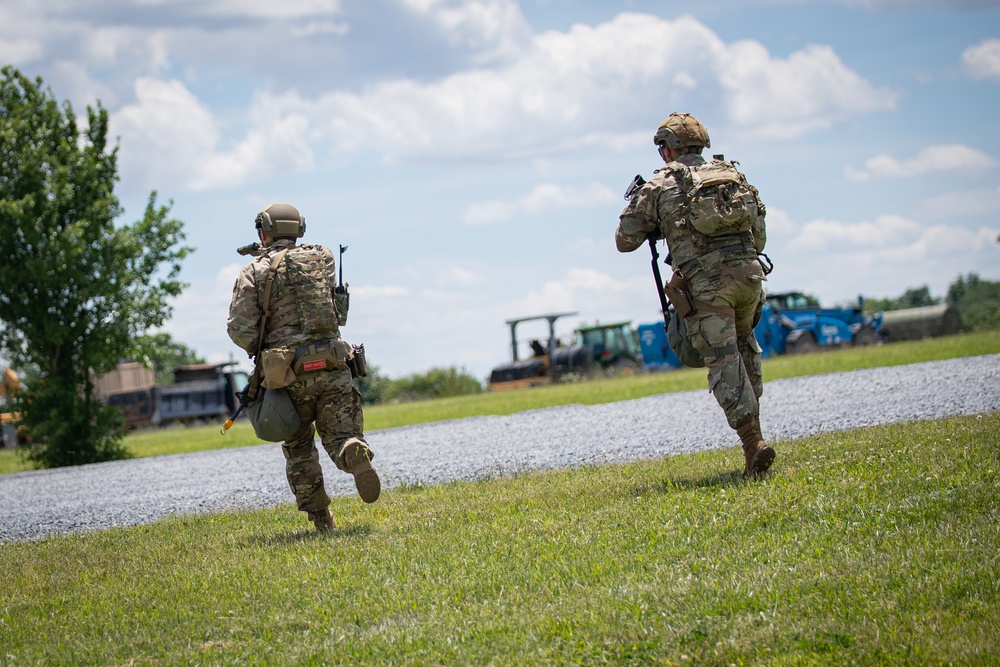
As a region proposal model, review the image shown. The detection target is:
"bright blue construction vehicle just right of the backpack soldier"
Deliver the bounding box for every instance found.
[754,292,883,358]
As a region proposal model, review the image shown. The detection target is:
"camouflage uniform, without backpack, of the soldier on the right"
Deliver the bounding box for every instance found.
[615,153,766,429]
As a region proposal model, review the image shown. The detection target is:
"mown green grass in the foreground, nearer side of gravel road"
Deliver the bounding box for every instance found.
[0,413,1000,666]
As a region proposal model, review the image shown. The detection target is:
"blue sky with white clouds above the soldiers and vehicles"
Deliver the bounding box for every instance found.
[0,0,1000,377]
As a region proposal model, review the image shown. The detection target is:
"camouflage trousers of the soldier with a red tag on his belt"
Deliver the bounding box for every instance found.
[281,369,368,518]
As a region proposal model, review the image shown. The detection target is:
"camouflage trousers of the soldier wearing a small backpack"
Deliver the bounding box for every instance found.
[685,260,764,429]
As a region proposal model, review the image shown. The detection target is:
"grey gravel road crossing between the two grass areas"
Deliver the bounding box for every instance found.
[0,354,1000,543]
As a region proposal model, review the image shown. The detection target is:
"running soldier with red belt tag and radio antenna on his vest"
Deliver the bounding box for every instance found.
[228,204,381,531]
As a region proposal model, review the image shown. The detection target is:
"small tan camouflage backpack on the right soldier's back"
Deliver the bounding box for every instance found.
[666,159,759,236]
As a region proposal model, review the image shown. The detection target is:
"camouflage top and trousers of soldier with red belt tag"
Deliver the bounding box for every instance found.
[228,239,372,520]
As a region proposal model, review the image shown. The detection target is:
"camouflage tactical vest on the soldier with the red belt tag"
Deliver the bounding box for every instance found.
[267,244,339,339]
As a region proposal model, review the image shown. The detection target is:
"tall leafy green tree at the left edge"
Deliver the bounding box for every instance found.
[0,67,191,467]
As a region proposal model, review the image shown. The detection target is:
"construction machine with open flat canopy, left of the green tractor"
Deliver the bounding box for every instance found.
[486,312,593,391]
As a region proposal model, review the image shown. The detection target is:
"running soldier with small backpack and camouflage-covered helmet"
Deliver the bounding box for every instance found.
[615,113,775,478]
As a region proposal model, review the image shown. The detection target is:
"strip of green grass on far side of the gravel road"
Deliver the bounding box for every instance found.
[0,330,1000,474]
